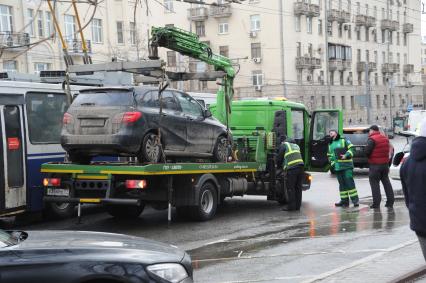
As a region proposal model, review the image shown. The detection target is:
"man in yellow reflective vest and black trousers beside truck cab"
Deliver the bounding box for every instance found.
[277,140,305,211]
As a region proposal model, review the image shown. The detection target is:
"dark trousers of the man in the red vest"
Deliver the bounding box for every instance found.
[368,164,395,206]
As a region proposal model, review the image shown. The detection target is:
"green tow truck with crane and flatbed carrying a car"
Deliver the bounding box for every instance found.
[41,28,342,221]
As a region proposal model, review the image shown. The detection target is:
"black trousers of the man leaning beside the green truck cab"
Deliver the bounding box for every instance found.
[286,166,305,210]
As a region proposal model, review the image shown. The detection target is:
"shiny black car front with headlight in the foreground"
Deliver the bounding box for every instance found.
[0,229,193,283]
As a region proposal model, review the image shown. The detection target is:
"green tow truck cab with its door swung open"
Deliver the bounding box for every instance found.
[210,98,343,171]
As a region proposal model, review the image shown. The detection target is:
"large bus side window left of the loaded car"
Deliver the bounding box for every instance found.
[25,92,68,144]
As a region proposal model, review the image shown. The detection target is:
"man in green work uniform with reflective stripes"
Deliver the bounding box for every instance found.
[327,130,359,207]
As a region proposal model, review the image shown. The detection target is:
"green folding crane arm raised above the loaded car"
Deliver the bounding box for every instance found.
[150,27,236,125]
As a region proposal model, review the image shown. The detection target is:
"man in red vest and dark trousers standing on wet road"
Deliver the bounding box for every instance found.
[365,125,395,208]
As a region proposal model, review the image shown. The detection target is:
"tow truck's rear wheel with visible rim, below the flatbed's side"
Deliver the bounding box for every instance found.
[191,182,217,221]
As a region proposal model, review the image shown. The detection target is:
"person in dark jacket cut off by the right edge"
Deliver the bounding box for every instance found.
[400,120,426,260]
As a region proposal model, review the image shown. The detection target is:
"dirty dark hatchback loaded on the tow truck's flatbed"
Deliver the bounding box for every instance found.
[61,87,228,163]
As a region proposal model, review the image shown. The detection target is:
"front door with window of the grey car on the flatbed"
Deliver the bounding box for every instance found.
[175,92,212,153]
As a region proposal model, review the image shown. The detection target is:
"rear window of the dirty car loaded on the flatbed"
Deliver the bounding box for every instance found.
[72,90,134,106]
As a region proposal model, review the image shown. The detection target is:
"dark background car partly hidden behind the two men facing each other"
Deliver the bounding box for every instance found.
[343,125,394,168]
